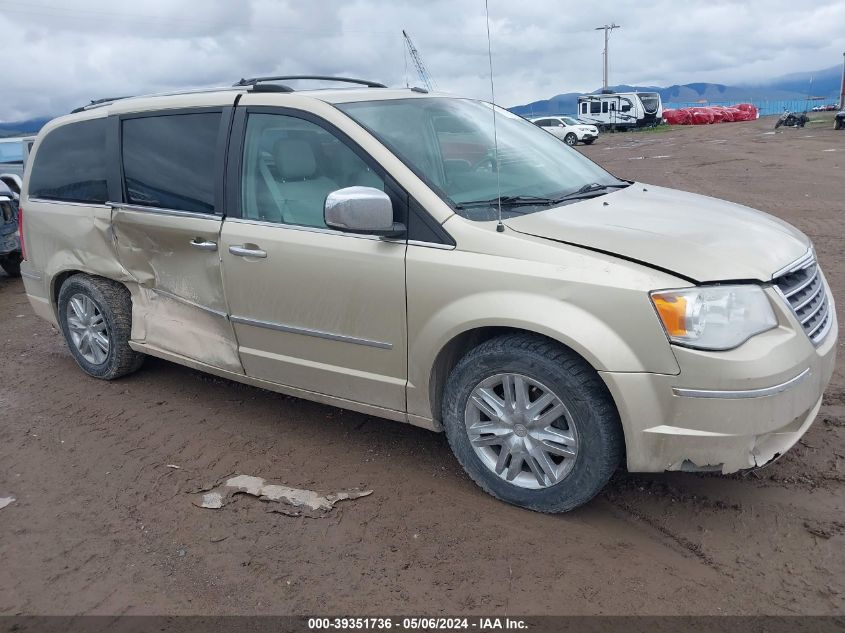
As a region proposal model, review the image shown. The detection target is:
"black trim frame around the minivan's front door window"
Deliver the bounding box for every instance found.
[224,105,456,248]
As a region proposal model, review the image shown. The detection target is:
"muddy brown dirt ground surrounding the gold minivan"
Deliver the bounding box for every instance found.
[0,119,845,615]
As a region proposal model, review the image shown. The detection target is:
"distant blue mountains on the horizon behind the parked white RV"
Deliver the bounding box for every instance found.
[508,66,842,117]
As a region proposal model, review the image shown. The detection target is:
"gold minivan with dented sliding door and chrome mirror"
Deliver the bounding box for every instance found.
[20,77,837,512]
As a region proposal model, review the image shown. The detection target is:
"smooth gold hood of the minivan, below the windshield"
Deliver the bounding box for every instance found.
[505,183,810,282]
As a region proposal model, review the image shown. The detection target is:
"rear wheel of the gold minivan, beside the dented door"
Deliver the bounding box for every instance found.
[58,275,144,380]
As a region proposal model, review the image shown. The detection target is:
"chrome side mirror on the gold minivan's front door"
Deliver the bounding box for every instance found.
[324,187,405,237]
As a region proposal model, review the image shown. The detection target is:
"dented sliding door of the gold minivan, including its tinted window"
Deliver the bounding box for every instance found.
[112,112,243,373]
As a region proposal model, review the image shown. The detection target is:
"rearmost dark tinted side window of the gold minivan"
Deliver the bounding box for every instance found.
[29,119,108,204]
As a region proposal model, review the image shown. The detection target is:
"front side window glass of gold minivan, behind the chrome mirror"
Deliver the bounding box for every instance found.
[241,114,385,228]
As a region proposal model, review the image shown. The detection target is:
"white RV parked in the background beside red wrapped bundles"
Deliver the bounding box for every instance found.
[578,92,663,132]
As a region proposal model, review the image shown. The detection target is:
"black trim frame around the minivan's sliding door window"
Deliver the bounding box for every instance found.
[113,106,234,218]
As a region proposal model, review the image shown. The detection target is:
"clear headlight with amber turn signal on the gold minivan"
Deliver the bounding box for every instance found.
[651,285,777,350]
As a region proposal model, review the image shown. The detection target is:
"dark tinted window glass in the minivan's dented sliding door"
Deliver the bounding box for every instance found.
[123,112,221,213]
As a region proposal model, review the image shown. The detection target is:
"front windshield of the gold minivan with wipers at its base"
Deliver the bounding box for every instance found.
[337,97,620,220]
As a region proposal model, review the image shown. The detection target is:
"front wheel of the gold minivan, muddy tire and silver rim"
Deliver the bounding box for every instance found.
[442,334,624,512]
